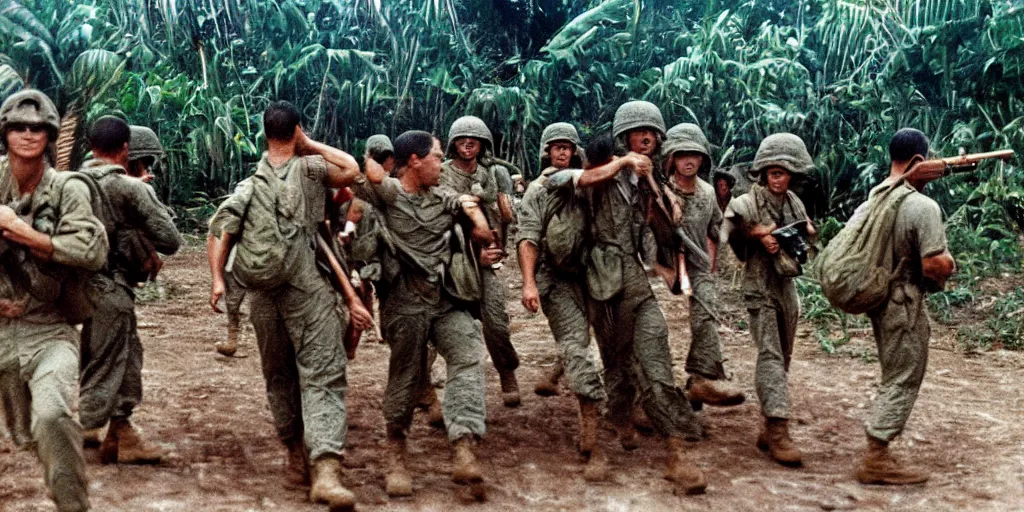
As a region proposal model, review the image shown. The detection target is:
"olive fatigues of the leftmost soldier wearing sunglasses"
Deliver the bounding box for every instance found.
[0,162,109,511]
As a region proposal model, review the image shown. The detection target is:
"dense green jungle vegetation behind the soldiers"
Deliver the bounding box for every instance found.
[0,0,1024,348]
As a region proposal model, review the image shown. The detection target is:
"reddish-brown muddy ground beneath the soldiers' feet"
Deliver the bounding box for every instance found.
[0,245,1024,512]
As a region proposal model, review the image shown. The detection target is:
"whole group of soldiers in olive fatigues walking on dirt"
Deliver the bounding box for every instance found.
[0,91,954,510]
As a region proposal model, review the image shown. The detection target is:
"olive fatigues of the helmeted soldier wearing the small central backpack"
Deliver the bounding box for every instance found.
[516,167,606,400]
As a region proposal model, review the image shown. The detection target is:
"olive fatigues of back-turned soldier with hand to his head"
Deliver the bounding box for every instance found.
[210,155,348,461]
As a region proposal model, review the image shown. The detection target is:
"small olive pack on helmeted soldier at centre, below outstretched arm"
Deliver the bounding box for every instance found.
[541,170,590,273]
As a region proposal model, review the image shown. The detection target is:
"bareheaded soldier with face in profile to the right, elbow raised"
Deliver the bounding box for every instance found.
[367,131,501,497]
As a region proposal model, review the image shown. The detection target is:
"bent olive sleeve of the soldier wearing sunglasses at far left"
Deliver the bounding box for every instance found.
[50,179,110,271]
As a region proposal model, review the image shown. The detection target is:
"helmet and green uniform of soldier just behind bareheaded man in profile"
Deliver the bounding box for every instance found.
[439,116,519,380]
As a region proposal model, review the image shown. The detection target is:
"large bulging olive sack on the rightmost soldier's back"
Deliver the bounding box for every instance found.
[815,180,914,314]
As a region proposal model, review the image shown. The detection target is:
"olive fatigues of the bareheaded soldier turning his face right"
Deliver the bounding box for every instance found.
[365,177,485,441]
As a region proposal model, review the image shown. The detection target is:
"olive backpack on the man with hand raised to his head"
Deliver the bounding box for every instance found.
[231,156,308,290]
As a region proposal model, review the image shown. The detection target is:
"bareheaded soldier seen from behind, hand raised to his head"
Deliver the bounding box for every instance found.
[208,101,370,510]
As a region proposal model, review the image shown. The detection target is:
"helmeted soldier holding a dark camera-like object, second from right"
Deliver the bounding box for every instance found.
[722,133,814,466]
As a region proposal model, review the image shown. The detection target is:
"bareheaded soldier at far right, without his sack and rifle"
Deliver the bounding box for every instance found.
[857,128,956,485]
